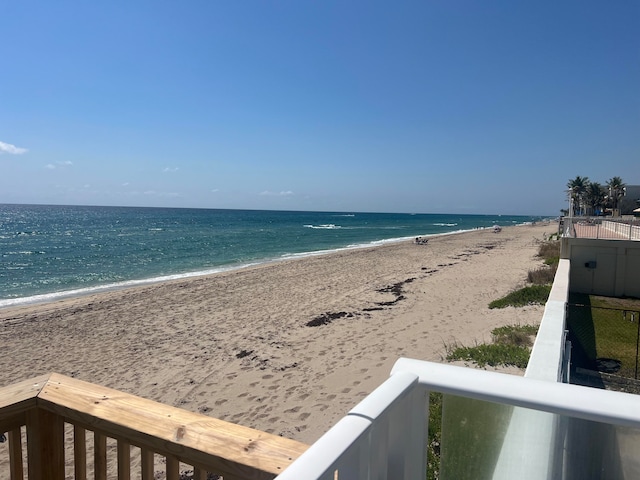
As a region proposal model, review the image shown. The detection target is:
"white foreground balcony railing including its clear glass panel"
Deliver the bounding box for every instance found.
[277,359,640,480]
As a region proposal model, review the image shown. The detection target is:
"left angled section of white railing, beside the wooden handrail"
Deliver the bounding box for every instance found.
[276,372,427,480]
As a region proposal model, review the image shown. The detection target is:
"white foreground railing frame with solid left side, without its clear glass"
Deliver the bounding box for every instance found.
[277,358,640,480]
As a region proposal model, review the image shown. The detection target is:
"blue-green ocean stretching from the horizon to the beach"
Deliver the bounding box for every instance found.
[0,205,541,307]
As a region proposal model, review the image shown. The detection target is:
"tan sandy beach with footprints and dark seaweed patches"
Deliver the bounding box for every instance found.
[0,223,557,443]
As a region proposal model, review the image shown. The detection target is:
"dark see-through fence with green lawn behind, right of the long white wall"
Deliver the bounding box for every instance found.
[567,304,640,380]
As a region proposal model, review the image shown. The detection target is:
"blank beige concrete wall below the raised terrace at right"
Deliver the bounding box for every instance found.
[560,237,640,298]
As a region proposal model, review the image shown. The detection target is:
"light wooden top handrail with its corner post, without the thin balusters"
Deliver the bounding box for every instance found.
[0,373,308,480]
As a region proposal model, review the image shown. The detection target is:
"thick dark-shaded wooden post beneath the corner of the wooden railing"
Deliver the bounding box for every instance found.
[27,408,65,480]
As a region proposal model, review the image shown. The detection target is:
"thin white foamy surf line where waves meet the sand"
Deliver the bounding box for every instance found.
[0,223,528,312]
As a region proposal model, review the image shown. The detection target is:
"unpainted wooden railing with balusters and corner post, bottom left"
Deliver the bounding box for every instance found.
[0,373,308,480]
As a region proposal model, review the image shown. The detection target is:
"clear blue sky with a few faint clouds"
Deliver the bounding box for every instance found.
[0,0,640,215]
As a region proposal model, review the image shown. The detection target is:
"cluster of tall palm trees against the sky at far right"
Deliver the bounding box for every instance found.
[563,175,636,217]
